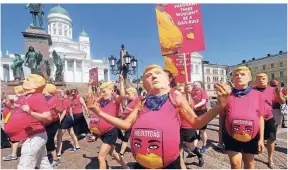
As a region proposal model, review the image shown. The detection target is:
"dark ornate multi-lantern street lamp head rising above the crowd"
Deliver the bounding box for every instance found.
[108,44,137,87]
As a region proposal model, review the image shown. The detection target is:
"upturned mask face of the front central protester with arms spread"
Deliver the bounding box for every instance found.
[143,68,169,92]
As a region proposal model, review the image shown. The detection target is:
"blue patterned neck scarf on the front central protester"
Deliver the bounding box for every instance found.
[145,93,168,111]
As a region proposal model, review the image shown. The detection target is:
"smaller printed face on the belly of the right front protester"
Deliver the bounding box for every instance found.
[232,119,254,142]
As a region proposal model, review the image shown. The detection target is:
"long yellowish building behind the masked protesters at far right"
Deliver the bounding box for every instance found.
[228,51,287,87]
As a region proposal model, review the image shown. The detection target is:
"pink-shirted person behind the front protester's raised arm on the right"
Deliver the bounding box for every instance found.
[189,81,208,153]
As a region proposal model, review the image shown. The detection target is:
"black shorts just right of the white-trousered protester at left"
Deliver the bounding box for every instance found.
[45,120,60,152]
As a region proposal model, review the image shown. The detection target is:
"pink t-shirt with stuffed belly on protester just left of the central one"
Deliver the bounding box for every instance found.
[89,98,120,135]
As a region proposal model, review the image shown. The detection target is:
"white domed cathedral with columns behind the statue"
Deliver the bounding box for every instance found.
[0,5,110,83]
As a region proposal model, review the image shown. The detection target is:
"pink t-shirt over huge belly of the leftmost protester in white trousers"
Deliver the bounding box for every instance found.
[4,93,49,141]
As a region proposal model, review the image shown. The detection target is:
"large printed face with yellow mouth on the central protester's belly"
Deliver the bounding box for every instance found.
[131,129,163,169]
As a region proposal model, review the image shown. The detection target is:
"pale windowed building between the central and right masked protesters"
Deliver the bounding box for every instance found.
[203,61,228,97]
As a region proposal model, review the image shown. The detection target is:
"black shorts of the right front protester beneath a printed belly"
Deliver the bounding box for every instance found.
[223,129,259,154]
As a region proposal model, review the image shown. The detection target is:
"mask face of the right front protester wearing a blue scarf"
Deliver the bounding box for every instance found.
[233,70,251,88]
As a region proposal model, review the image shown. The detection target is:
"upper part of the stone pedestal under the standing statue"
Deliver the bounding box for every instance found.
[22,27,52,59]
